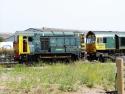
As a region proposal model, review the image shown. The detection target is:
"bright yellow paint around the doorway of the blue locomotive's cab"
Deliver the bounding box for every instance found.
[19,35,30,54]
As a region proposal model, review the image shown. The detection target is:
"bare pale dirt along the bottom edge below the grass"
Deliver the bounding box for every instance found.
[0,86,106,94]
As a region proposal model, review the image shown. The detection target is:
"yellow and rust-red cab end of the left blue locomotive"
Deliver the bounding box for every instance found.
[14,35,30,62]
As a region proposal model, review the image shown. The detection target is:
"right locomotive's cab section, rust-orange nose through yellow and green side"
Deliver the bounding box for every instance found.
[86,31,115,62]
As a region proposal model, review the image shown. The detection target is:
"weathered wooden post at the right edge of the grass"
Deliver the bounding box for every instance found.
[116,58,125,94]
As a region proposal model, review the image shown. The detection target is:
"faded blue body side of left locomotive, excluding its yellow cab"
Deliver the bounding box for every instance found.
[29,32,81,59]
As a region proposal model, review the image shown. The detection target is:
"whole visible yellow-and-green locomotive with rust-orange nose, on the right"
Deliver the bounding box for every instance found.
[86,31,125,62]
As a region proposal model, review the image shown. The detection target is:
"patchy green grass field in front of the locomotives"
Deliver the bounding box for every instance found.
[0,61,115,94]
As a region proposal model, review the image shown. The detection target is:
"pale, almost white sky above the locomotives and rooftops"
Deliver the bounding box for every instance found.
[0,0,125,33]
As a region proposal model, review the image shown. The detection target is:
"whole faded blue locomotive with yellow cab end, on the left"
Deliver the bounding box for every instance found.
[11,28,81,62]
